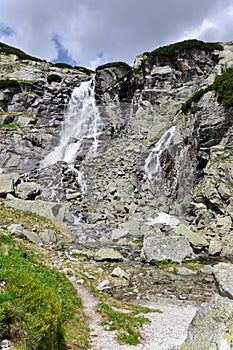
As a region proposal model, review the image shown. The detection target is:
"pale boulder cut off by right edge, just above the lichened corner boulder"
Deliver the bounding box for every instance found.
[213,263,233,299]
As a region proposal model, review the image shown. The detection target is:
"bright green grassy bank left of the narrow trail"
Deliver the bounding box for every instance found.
[0,232,88,350]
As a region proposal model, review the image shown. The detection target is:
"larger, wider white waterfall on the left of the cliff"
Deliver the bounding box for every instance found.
[41,78,101,186]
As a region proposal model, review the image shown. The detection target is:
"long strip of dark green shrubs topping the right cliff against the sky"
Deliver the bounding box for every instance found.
[149,39,223,57]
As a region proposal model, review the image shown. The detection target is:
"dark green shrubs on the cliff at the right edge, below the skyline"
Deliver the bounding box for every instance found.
[181,68,233,114]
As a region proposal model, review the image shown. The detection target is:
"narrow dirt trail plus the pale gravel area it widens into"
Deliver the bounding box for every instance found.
[75,285,196,350]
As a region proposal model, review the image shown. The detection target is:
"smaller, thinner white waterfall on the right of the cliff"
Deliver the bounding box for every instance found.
[144,126,176,182]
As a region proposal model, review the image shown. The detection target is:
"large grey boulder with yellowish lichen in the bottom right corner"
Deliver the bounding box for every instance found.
[180,295,233,350]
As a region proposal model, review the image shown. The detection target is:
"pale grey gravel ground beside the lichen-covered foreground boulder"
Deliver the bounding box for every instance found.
[87,300,197,350]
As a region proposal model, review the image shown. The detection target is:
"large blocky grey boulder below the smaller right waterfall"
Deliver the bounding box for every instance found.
[141,235,193,263]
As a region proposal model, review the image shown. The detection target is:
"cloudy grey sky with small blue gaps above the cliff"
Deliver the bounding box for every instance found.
[0,0,233,69]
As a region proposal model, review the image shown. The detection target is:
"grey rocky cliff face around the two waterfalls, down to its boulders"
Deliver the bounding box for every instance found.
[0,43,233,262]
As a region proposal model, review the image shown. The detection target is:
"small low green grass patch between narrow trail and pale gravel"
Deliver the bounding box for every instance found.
[97,302,153,345]
